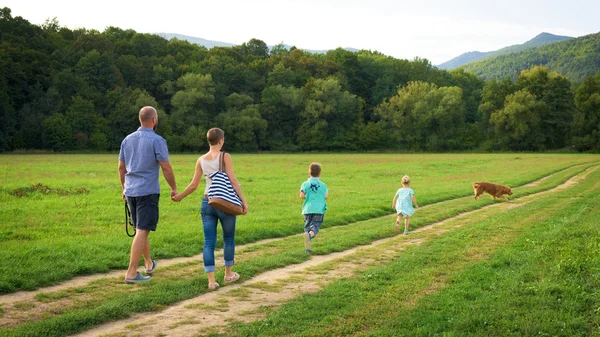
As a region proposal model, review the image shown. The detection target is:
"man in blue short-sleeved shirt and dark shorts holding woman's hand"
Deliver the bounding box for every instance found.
[119,106,177,283]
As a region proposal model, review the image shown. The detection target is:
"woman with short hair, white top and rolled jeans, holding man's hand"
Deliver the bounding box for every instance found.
[172,128,248,289]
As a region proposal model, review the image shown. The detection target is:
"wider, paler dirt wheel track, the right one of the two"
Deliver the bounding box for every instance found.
[72,167,598,336]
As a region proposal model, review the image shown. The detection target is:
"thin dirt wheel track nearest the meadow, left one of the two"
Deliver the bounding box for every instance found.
[0,163,589,307]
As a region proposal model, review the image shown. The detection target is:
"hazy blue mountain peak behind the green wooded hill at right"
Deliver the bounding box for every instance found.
[437,32,572,69]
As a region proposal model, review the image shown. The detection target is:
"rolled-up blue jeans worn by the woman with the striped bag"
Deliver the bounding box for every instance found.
[200,198,236,273]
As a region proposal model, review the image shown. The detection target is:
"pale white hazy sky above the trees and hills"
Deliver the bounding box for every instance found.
[0,0,600,64]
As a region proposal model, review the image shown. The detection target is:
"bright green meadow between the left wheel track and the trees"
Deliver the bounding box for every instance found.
[0,154,600,293]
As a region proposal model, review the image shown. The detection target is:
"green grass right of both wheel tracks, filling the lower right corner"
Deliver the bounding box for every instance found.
[228,170,600,336]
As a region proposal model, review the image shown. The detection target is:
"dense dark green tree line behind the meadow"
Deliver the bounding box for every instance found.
[0,7,600,152]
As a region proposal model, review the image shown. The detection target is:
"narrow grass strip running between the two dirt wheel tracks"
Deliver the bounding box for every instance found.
[0,158,589,336]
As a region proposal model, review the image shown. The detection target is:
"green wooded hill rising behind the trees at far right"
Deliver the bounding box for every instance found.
[461,33,600,82]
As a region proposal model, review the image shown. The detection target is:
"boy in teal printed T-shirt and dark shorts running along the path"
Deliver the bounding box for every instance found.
[300,163,329,253]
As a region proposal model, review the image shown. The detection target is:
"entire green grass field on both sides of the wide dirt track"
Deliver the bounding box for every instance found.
[0,154,600,336]
